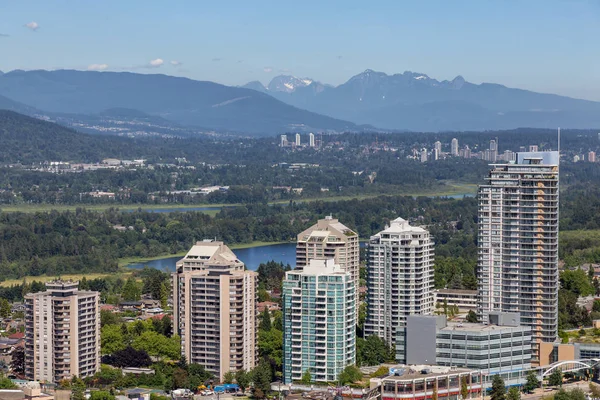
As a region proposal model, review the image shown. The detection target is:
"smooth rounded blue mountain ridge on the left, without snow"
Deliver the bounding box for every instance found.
[0,70,358,135]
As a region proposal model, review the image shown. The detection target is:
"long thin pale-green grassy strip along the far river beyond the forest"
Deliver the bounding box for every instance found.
[0,182,477,216]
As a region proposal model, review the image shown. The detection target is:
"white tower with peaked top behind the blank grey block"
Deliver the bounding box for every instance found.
[365,218,434,345]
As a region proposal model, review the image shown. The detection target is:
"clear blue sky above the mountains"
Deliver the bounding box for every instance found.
[0,0,600,101]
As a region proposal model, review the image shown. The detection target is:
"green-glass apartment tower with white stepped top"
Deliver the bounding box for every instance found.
[283,259,357,384]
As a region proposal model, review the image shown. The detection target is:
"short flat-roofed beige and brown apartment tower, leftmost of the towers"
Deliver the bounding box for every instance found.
[25,280,100,382]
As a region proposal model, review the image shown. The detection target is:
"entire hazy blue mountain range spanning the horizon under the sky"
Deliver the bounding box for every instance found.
[0,70,600,136]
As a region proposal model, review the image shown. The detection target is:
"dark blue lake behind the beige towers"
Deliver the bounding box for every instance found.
[128,243,296,272]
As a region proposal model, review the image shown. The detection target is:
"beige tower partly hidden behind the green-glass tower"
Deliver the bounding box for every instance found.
[296,216,360,313]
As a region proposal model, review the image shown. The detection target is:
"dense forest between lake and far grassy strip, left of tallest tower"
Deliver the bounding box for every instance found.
[0,196,476,278]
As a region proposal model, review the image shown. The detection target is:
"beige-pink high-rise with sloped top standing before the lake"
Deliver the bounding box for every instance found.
[173,241,258,378]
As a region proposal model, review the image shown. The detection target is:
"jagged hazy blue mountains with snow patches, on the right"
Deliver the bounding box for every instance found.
[245,70,600,131]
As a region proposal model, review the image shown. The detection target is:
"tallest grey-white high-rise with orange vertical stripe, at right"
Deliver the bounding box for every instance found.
[477,151,559,356]
